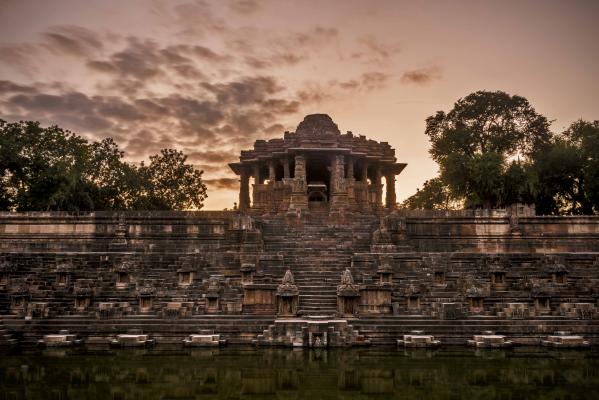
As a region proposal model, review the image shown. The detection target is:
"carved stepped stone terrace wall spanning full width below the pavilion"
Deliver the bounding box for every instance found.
[0,209,599,343]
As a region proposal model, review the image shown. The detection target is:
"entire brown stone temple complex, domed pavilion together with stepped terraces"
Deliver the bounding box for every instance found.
[0,115,599,347]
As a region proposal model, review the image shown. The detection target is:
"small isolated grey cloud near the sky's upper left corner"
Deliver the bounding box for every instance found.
[43,25,103,57]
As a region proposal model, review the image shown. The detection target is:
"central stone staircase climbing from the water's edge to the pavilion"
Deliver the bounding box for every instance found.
[262,212,378,315]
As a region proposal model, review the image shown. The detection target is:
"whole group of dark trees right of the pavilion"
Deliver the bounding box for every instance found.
[401,91,599,215]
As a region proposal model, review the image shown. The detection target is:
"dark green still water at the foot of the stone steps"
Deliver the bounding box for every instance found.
[0,347,599,400]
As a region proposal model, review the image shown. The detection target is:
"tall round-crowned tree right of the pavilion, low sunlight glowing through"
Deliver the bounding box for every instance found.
[425,91,551,208]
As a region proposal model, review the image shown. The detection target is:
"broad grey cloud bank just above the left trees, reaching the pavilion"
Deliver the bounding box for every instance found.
[0,71,300,166]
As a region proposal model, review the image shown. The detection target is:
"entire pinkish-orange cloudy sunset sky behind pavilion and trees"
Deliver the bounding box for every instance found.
[0,0,599,210]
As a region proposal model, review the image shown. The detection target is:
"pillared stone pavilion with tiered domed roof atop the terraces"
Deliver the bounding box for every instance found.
[229,114,406,213]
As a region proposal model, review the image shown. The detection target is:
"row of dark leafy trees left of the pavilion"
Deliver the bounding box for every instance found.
[0,120,207,211]
